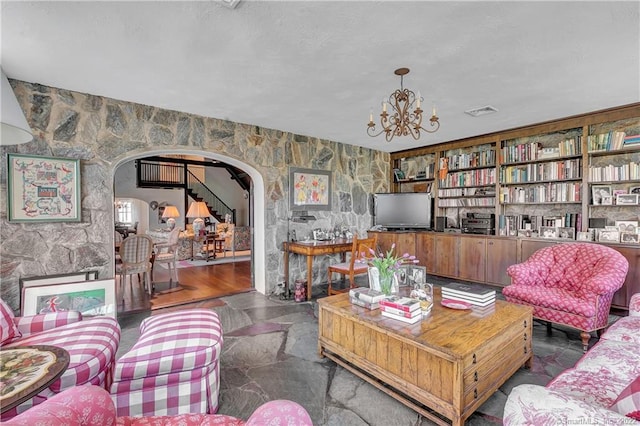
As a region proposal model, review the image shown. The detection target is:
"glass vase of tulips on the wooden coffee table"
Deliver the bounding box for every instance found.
[363,243,418,295]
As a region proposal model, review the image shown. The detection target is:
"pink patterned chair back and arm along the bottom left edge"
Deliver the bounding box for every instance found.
[6,386,313,426]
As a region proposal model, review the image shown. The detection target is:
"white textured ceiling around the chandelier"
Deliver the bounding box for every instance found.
[1,0,640,152]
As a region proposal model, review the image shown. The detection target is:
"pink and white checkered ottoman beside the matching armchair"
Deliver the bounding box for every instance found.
[111,309,222,416]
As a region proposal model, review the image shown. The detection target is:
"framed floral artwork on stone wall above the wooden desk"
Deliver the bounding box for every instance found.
[289,167,331,210]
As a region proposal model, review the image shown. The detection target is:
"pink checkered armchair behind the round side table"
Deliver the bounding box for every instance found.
[0,299,120,421]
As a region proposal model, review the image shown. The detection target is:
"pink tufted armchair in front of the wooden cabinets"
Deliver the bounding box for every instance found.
[502,243,629,351]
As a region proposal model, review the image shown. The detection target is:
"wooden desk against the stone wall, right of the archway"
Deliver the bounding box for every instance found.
[282,238,353,300]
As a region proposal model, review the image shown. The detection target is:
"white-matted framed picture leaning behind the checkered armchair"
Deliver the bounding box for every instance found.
[22,278,117,318]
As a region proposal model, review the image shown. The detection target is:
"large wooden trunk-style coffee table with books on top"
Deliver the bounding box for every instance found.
[318,288,533,425]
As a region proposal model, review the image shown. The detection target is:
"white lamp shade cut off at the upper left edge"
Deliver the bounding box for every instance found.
[0,68,33,145]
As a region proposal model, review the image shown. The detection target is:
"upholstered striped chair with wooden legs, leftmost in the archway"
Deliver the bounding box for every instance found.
[116,235,153,300]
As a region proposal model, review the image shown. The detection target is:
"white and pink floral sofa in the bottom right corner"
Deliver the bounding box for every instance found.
[503,310,640,426]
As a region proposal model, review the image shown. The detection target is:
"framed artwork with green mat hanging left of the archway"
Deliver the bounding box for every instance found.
[7,154,81,222]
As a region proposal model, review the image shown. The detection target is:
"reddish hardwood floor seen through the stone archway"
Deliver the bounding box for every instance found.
[116,261,253,313]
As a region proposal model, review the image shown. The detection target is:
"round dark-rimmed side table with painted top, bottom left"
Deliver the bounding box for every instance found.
[0,345,69,413]
